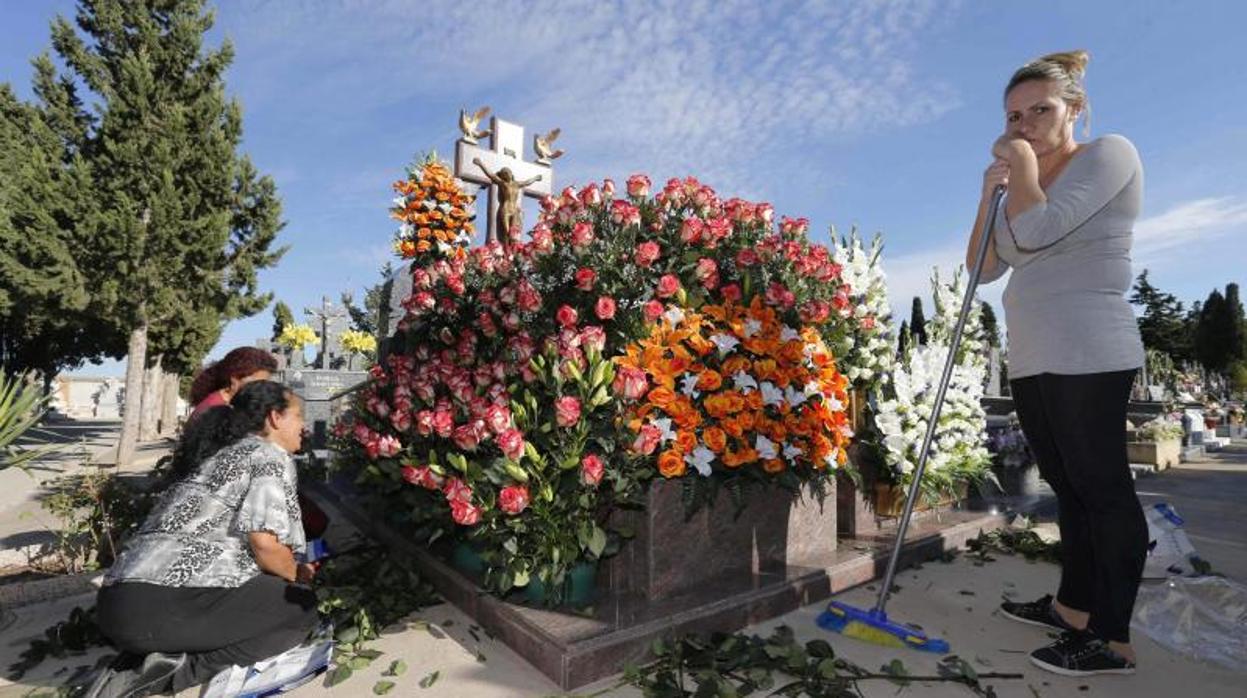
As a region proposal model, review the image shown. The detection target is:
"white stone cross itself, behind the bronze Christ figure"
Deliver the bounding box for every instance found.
[455,116,554,243]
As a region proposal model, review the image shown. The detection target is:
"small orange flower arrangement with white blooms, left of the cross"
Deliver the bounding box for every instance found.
[390,155,475,259]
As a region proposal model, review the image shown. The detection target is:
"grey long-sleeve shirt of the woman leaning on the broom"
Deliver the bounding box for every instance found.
[981,136,1143,378]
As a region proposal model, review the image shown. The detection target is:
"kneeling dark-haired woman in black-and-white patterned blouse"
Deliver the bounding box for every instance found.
[90,380,317,697]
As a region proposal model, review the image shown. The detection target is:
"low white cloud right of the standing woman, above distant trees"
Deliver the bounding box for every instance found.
[1135,196,1247,267]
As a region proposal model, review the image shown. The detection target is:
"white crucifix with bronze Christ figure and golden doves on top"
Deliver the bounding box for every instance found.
[455,107,562,243]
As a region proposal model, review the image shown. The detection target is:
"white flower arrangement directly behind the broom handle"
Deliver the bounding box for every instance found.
[875,266,991,500]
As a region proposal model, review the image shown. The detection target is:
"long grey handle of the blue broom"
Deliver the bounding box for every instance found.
[874,184,1005,613]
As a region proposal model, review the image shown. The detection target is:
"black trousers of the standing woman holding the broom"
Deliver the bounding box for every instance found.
[1010,370,1147,642]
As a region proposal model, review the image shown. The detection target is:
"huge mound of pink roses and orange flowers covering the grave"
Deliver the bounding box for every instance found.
[334,163,858,593]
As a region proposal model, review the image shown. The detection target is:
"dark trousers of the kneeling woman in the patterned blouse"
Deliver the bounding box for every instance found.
[96,575,317,691]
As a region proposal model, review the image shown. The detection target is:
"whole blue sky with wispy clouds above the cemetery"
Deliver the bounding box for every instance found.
[0,0,1247,373]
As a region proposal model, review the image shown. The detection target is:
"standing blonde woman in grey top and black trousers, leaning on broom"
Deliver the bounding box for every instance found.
[966,51,1147,676]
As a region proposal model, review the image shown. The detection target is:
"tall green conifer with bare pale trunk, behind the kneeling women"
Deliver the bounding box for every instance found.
[45,0,284,461]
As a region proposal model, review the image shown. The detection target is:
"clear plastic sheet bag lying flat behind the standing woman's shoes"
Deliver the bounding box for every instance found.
[1131,576,1247,672]
